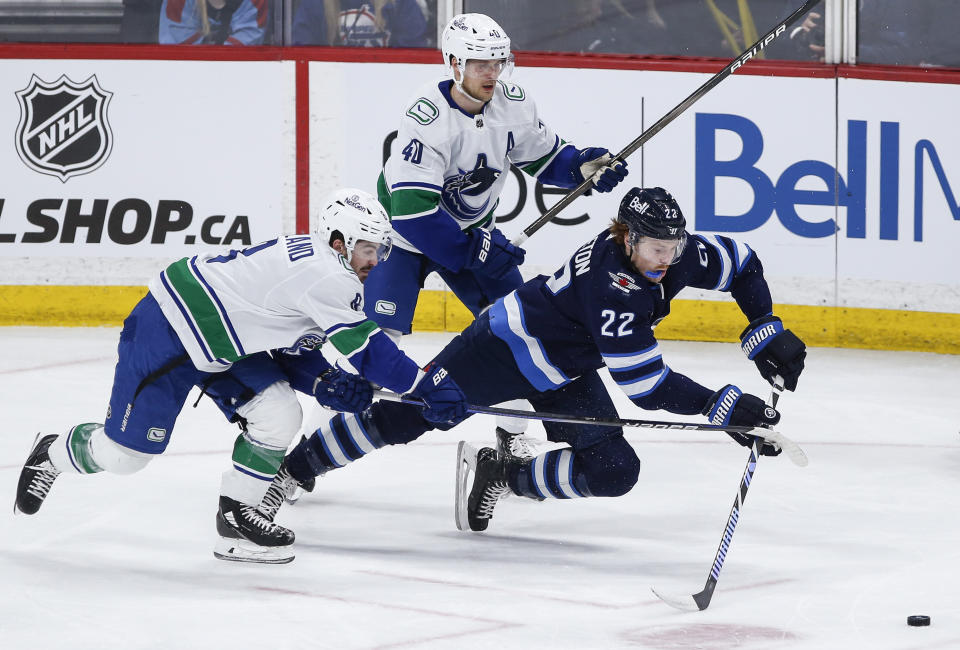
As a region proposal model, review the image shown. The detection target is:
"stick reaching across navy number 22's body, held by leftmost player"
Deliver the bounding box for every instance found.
[373,390,808,467]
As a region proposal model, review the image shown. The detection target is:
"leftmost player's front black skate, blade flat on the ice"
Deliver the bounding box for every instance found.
[213,495,295,564]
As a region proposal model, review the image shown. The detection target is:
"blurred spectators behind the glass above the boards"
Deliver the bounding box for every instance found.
[0,0,960,67]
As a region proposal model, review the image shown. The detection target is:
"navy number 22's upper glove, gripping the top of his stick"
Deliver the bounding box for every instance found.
[740,316,807,390]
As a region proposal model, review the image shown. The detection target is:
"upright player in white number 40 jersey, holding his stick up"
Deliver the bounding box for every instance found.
[365,14,627,455]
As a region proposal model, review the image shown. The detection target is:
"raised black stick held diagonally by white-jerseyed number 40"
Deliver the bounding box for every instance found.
[512,0,820,246]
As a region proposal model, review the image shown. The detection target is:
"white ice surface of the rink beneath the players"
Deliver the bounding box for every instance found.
[0,328,960,650]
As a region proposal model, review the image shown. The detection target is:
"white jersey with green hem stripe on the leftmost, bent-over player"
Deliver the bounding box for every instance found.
[150,234,379,372]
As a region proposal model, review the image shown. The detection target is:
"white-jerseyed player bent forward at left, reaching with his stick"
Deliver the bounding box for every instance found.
[15,190,466,563]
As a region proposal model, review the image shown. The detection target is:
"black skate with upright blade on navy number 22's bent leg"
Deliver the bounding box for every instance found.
[455,441,510,531]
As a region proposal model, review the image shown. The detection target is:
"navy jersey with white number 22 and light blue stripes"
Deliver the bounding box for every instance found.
[490,232,773,415]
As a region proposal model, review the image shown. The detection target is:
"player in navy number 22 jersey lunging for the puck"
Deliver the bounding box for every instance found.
[261,188,806,530]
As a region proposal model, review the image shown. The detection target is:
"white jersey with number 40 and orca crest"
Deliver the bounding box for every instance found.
[379,79,567,252]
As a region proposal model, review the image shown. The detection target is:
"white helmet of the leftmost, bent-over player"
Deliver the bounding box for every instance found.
[317,187,393,262]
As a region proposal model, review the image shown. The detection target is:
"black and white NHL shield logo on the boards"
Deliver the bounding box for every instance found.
[16,75,113,183]
